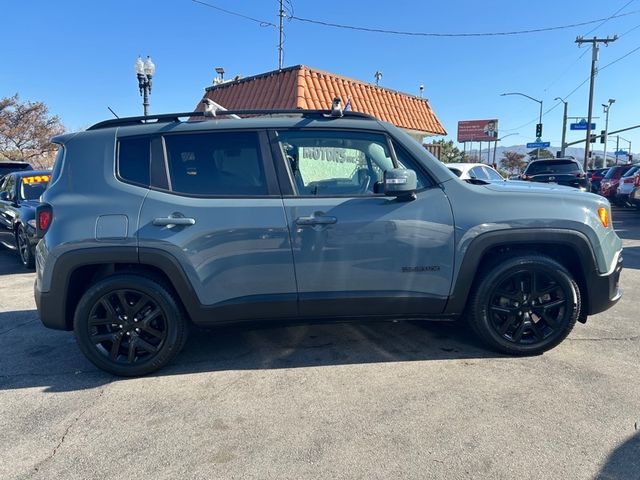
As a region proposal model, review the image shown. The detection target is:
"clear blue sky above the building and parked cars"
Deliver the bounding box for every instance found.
[0,0,640,156]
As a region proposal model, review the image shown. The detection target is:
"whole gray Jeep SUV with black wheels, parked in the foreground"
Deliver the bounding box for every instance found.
[35,110,622,375]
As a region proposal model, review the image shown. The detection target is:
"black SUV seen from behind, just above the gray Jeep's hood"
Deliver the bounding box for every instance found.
[520,158,591,192]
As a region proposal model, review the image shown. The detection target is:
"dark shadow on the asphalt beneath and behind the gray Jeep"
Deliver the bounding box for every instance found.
[0,310,501,392]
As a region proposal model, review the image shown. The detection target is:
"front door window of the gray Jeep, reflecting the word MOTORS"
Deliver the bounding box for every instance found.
[278,130,394,196]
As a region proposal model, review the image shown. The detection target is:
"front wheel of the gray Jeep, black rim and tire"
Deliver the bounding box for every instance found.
[468,254,580,355]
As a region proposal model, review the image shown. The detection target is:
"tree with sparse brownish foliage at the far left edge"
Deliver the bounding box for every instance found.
[0,94,64,168]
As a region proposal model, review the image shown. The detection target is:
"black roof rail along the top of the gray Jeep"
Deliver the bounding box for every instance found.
[87,108,375,130]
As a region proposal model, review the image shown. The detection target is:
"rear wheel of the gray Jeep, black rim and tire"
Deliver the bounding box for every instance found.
[73,274,188,377]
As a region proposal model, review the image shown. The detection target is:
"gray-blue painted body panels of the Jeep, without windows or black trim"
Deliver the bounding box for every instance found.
[37,117,621,318]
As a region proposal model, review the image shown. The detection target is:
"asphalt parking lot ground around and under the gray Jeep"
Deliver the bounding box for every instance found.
[0,209,640,479]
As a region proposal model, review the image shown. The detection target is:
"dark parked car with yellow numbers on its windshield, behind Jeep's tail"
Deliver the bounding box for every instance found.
[0,170,51,268]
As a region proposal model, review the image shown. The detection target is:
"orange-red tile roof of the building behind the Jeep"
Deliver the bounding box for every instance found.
[197,65,447,138]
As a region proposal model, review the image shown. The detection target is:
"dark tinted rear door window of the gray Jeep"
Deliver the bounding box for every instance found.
[164,132,268,196]
